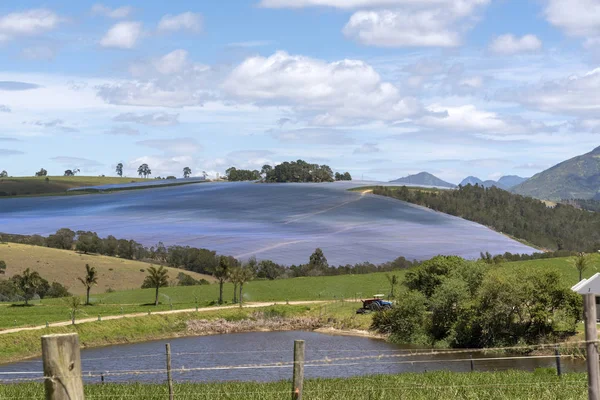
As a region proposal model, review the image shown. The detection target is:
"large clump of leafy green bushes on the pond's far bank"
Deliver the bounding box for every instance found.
[372,256,582,348]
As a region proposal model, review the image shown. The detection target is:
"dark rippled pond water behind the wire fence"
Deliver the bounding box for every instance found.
[0,331,585,383]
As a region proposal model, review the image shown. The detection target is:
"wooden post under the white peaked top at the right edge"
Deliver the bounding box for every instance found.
[583,293,600,400]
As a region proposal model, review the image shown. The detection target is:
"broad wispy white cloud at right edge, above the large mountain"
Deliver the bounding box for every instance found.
[499,68,600,118]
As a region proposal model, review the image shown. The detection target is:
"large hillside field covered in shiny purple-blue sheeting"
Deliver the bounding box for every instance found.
[0,183,534,265]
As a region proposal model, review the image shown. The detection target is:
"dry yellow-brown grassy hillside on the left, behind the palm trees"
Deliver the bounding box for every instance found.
[0,243,214,294]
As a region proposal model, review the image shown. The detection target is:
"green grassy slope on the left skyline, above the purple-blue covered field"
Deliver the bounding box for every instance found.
[0,176,147,196]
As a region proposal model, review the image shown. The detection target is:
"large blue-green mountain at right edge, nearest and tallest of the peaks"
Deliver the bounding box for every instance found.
[512,147,600,200]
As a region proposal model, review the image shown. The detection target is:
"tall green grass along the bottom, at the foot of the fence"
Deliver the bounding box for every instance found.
[0,370,587,400]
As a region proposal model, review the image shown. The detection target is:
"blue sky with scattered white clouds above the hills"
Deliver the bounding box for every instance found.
[0,0,600,183]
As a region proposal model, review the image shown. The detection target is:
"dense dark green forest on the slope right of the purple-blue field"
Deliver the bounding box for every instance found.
[373,185,600,253]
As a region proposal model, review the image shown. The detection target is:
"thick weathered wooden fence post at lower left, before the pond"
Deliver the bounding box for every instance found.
[42,333,84,400]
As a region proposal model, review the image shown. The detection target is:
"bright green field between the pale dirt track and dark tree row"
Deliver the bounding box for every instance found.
[0,255,600,329]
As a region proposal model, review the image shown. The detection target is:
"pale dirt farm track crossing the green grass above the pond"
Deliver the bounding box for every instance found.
[0,300,327,335]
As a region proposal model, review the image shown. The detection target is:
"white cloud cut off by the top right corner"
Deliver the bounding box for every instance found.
[544,0,600,37]
